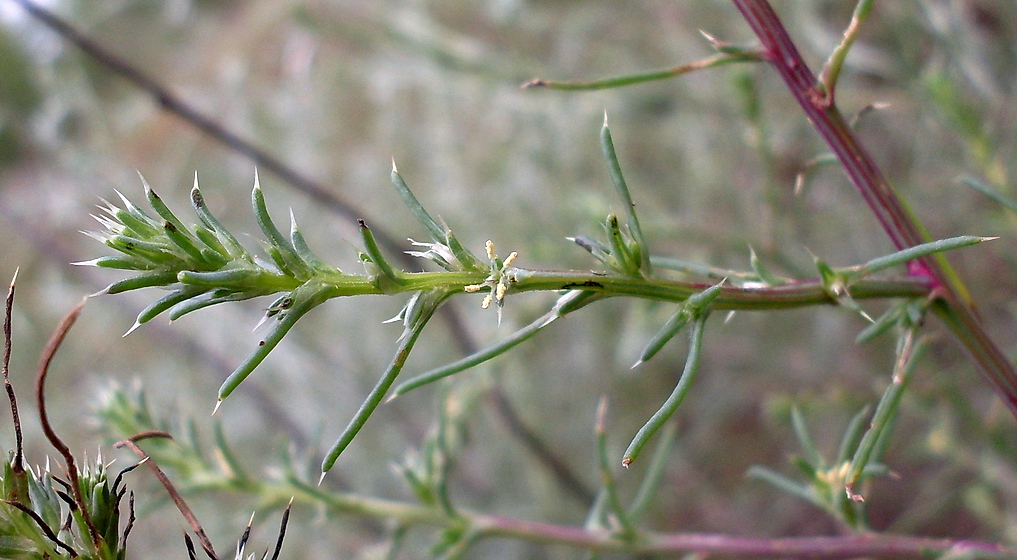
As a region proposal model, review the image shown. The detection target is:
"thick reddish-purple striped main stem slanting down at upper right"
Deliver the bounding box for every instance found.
[732,0,1017,417]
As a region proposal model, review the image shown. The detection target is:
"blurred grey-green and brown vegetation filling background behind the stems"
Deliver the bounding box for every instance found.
[0,0,1017,558]
